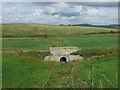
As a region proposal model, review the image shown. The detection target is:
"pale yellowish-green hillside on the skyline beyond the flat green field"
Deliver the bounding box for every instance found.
[2,23,117,37]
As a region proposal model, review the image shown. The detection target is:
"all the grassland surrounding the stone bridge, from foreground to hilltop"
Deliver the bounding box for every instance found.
[0,23,118,88]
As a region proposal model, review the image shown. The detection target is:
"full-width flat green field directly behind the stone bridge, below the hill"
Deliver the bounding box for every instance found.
[3,35,118,50]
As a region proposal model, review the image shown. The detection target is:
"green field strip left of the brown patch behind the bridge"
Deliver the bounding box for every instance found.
[2,39,54,50]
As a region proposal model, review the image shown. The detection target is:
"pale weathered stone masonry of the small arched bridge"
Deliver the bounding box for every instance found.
[44,47,83,62]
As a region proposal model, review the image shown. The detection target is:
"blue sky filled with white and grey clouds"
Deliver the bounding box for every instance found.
[0,2,118,24]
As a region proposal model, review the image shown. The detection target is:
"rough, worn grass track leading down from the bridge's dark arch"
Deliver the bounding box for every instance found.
[44,63,81,88]
